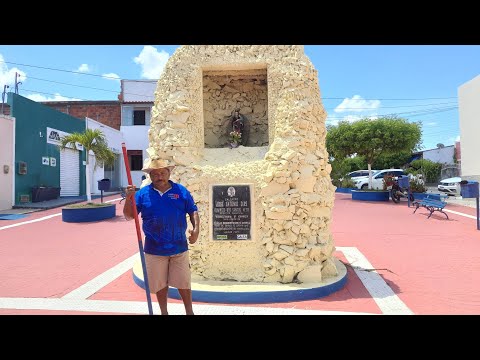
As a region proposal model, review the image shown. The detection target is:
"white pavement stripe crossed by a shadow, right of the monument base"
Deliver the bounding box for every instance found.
[336,246,413,315]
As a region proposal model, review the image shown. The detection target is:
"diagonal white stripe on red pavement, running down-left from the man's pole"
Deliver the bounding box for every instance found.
[62,253,140,300]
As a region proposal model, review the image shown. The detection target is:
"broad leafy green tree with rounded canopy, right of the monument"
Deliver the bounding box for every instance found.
[326,117,422,188]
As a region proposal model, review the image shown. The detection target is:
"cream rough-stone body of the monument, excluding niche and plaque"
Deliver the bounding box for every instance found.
[145,45,337,283]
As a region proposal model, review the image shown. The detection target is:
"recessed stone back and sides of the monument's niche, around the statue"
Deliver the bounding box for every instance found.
[203,69,268,148]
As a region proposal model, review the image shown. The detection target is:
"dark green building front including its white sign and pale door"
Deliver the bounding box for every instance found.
[8,93,85,205]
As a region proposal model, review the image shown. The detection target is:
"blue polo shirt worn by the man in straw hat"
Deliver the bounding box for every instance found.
[135,180,198,256]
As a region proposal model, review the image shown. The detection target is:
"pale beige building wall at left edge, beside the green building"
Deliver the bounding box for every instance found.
[0,115,15,210]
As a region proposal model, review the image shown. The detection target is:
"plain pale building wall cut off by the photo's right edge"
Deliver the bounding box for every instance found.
[458,75,480,181]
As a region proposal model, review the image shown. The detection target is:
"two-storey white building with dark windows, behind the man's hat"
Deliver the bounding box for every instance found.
[120,80,158,186]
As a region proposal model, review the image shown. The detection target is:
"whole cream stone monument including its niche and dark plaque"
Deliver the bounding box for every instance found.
[146,45,339,283]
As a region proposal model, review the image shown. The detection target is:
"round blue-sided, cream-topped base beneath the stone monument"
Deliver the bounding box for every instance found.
[132,260,347,304]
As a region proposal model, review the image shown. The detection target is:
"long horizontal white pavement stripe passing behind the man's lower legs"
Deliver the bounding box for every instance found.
[0,298,373,315]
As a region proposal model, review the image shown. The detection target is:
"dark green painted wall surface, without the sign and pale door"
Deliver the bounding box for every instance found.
[7,93,85,204]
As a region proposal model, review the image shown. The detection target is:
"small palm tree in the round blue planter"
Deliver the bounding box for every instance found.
[59,129,115,201]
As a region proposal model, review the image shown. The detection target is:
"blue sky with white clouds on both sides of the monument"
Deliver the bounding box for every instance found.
[0,45,480,149]
